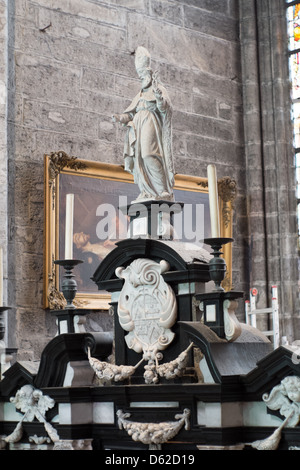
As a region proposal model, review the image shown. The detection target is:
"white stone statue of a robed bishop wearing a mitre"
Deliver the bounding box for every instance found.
[112,47,174,202]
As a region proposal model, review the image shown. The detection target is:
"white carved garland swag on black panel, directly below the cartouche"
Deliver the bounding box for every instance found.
[117,408,190,445]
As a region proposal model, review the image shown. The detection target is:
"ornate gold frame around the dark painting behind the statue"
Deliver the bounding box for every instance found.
[44,151,236,310]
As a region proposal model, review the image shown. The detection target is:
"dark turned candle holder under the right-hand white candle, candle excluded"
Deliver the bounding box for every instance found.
[204,238,234,292]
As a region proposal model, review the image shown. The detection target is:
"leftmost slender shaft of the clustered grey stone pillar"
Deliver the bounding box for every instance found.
[240,0,267,312]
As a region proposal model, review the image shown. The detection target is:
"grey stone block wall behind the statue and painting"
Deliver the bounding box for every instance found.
[4,0,247,360]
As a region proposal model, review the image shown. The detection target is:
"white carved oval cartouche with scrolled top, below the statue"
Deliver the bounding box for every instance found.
[116,258,177,361]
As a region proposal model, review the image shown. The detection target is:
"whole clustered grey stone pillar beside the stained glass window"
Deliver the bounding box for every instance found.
[240,0,300,341]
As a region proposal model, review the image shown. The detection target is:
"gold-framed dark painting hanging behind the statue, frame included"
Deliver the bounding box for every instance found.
[44,151,234,310]
